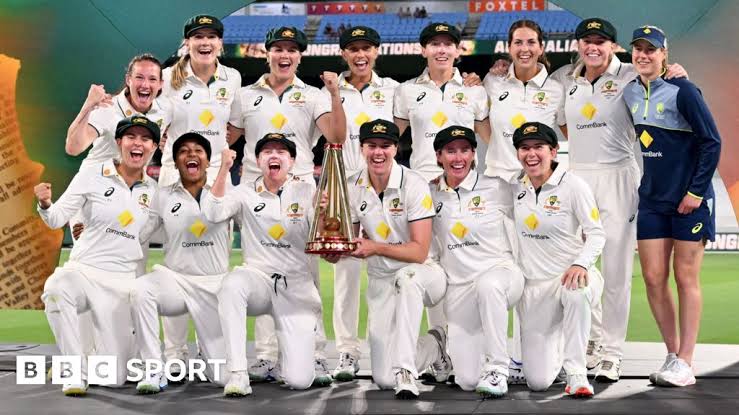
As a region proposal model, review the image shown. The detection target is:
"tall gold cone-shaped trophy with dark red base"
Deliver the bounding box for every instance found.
[305,143,357,254]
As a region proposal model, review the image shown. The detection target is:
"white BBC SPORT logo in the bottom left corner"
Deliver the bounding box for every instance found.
[15,356,226,386]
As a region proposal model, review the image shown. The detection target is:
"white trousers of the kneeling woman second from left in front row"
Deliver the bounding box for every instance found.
[131,265,226,384]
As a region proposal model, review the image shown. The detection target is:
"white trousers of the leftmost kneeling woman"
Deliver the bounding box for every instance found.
[41,261,136,385]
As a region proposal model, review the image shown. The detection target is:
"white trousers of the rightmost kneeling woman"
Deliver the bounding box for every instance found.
[517,267,603,391]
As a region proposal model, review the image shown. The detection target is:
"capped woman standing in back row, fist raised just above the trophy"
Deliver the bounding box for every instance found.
[229,27,347,384]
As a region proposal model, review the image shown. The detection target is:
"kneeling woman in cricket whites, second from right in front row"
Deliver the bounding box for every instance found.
[431,126,524,398]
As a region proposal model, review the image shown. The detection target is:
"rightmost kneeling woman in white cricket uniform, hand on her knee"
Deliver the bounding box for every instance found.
[512,122,605,397]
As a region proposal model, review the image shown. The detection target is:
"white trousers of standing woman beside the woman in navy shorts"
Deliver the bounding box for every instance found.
[573,159,641,359]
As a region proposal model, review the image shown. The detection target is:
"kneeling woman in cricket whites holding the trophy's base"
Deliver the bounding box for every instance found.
[327,119,451,399]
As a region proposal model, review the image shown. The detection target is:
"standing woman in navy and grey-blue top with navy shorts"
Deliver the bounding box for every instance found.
[624,26,721,386]
